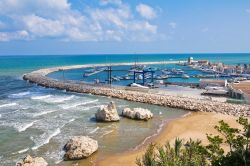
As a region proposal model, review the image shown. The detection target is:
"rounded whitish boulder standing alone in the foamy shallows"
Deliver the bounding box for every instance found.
[64,136,98,160]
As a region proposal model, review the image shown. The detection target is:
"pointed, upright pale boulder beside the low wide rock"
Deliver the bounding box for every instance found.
[95,102,120,122]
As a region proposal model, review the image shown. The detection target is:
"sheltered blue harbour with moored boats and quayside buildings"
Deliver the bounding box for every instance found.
[48,57,250,103]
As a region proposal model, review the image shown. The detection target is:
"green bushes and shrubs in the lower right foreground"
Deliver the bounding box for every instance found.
[136,117,250,166]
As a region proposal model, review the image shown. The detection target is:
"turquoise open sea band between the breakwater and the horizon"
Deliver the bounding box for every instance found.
[0,53,250,76]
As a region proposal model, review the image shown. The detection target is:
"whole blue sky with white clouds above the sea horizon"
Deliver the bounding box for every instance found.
[0,0,250,55]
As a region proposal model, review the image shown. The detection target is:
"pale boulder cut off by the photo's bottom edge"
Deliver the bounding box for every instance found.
[16,155,48,166]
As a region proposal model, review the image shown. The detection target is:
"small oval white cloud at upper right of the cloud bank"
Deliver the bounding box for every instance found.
[136,3,156,19]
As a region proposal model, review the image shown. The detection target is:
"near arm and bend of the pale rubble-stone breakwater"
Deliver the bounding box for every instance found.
[23,61,250,117]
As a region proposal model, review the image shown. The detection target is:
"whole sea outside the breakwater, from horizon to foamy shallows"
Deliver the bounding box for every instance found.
[0,53,250,166]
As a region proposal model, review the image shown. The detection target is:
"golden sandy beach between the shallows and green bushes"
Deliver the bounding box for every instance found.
[97,112,244,166]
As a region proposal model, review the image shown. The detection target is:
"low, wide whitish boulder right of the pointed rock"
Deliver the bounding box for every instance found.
[122,108,153,121]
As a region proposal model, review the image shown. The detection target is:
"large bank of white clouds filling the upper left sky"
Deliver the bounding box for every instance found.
[0,0,158,41]
